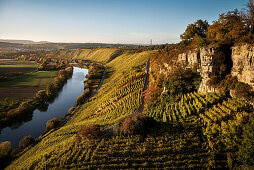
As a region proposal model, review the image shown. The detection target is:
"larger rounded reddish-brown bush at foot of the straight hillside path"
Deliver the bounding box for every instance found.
[120,115,149,135]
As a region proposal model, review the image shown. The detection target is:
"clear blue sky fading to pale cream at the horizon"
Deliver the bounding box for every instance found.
[0,0,248,44]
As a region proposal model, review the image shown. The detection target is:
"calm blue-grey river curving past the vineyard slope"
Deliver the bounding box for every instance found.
[0,67,88,148]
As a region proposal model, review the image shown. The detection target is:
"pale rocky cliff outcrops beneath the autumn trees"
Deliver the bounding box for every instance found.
[178,45,254,93]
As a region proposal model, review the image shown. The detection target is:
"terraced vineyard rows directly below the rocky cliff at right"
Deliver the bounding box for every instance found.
[146,89,253,168]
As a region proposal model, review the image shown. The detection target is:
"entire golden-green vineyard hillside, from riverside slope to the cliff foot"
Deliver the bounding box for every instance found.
[4,46,253,169]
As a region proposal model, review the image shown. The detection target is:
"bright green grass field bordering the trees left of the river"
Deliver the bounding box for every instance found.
[0,71,56,87]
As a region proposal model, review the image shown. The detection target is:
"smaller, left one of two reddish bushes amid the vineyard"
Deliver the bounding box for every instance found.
[76,125,101,141]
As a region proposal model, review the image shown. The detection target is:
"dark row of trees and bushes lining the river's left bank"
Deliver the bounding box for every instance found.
[0,67,73,128]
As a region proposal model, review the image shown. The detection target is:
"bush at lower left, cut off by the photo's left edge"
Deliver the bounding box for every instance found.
[0,141,12,164]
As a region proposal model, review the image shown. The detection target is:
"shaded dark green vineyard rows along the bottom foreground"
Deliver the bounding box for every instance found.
[9,123,212,169]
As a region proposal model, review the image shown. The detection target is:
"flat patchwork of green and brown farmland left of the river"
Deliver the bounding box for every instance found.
[0,59,56,99]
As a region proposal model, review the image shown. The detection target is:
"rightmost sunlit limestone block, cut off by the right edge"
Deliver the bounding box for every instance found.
[231,45,254,88]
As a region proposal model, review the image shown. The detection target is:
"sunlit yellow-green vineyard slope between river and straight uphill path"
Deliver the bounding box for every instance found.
[7,51,154,169]
